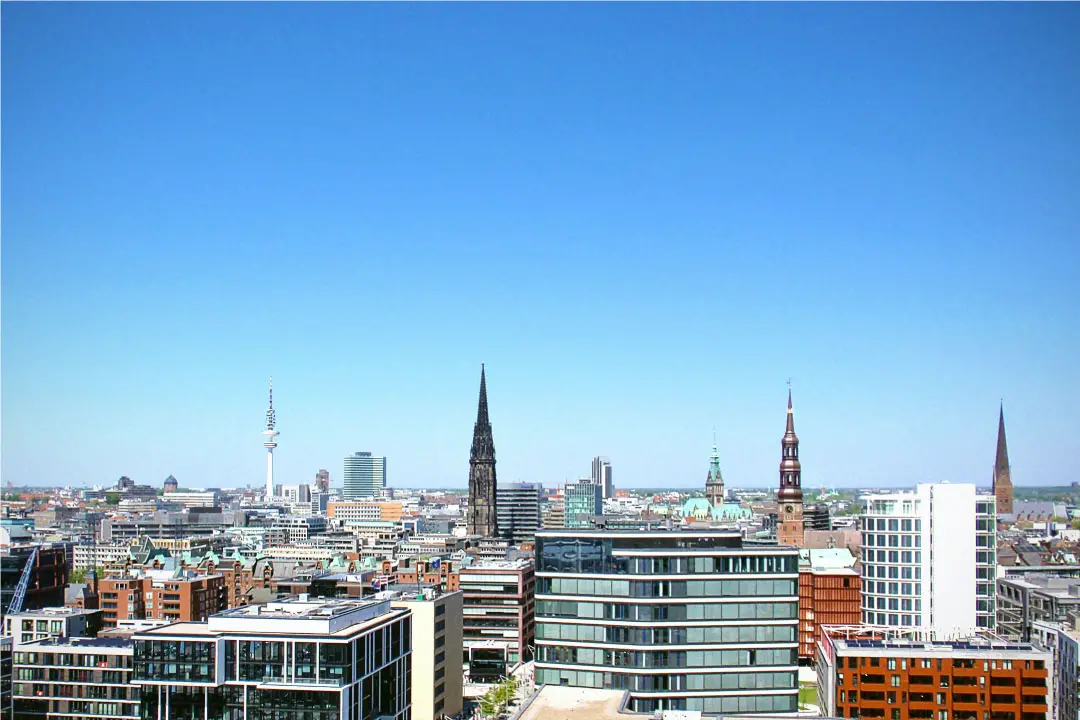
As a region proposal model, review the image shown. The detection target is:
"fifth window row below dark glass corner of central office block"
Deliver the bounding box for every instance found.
[536,667,795,692]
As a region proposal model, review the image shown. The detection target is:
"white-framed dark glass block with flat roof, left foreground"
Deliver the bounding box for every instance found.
[133,595,411,720]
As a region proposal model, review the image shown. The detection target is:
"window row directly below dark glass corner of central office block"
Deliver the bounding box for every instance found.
[537,578,795,598]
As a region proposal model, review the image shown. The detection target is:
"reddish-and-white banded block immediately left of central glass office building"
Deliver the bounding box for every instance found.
[458,560,536,682]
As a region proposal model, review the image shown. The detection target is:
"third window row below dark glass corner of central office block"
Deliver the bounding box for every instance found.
[537,623,795,644]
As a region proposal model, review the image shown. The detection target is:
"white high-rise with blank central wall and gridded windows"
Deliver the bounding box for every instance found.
[861,483,997,636]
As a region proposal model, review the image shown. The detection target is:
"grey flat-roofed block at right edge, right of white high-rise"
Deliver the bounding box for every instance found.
[998,572,1080,641]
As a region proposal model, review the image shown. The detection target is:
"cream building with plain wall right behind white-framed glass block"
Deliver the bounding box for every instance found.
[380,588,463,720]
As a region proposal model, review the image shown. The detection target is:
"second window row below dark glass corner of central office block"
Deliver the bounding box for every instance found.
[537,600,798,622]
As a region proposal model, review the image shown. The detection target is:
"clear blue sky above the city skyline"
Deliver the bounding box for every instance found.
[2,3,1080,487]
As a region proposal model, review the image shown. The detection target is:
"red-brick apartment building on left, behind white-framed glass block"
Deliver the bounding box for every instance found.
[98,571,228,627]
